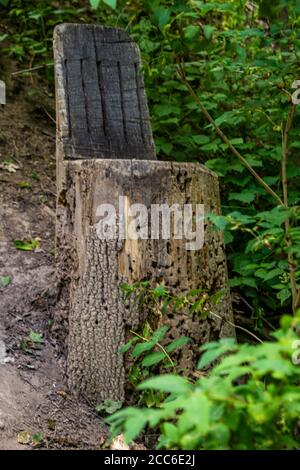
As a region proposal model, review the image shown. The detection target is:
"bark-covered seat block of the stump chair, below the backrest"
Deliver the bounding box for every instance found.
[57,159,234,402]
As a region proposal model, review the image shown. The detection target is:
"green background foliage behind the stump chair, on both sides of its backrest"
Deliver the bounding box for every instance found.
[1,0,300,316]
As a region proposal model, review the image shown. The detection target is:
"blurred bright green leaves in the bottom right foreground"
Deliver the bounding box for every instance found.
[107,312,300,450]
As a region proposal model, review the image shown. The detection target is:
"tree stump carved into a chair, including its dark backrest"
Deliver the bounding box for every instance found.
[54,25,234,403]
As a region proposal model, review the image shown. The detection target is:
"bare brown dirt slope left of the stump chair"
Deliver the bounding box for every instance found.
[0,62,104,449]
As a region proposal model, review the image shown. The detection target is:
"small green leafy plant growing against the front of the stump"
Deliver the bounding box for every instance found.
[119,281,227,406]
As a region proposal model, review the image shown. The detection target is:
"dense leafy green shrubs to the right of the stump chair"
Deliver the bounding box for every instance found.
[132,1,300,320]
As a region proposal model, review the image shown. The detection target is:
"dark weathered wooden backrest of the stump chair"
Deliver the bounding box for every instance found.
[54,24,156,160]
